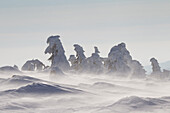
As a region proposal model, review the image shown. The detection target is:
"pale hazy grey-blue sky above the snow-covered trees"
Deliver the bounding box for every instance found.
[0,0,170,67]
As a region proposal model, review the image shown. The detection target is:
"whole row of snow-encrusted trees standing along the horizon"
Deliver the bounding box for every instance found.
[19,35,170,78]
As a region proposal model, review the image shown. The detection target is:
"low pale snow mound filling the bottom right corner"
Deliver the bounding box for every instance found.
[97,96,170,113]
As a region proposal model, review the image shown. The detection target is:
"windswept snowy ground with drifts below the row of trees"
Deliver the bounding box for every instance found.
[0,73,170,113]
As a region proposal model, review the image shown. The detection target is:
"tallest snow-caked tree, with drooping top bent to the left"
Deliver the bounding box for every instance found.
[45,35,70,71]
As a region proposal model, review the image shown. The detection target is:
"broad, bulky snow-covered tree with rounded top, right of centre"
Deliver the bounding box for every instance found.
[105,43,132,75]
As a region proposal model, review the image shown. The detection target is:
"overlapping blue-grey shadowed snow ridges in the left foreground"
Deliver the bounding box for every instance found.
[0,75,81,95]
